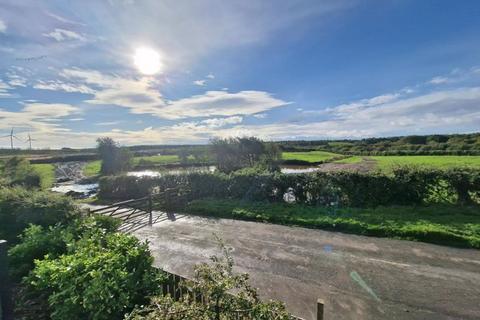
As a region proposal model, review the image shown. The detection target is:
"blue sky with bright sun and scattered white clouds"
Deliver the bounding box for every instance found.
[0,0,480,148]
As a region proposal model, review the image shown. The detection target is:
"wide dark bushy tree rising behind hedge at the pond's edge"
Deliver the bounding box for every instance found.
[211,137,281,173]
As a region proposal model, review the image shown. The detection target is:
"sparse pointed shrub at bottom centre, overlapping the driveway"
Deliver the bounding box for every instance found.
[126,241,290,320]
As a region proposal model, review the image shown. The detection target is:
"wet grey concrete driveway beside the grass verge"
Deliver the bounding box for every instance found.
[133,212,480,320]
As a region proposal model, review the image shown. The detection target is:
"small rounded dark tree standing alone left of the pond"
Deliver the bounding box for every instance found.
[97,137,132,175]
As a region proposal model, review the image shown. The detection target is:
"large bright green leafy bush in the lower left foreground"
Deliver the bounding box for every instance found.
[24,229,163,320]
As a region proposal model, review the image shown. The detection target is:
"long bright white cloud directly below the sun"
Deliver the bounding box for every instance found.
[57,69,288,120]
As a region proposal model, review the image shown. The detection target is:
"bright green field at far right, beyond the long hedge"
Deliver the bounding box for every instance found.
[369,156,480,171]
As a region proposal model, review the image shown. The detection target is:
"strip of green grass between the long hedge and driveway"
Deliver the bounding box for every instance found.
[186,199,480,249]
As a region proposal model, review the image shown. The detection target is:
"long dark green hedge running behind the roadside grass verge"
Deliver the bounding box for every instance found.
[99,167,480,207]
